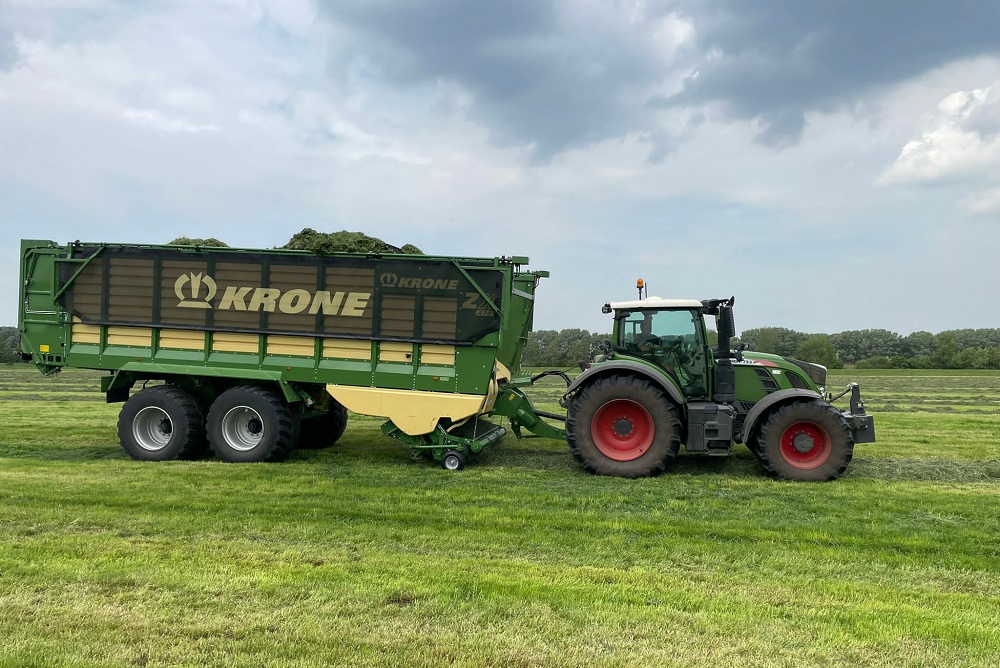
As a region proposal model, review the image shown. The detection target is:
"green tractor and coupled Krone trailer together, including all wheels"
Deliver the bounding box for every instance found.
[18,240,875,480]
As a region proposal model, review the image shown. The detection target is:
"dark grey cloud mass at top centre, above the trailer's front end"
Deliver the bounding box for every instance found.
[321,0,680,159]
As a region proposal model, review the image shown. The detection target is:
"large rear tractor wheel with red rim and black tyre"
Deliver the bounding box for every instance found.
[566,375,681,478]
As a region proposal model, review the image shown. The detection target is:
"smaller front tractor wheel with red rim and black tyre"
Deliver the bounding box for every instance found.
[756,401,854,481]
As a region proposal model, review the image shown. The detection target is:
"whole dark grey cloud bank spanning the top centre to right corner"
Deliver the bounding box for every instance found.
[320,0,1000,159]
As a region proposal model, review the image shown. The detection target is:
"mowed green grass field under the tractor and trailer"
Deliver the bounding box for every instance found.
[0,365,1000,667]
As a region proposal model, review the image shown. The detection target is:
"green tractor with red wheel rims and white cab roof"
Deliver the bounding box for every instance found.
[562,288,875,480]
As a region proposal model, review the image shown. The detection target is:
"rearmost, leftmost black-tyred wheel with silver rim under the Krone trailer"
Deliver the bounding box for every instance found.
[118,385,205,462]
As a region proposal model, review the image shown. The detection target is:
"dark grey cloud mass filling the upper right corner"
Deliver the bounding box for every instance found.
[657,0,1000,145]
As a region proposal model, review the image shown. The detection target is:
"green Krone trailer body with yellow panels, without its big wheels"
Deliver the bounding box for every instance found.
[18,240,547,464]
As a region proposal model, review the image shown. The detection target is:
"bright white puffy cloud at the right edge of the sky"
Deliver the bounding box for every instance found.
[878,82,1000,185]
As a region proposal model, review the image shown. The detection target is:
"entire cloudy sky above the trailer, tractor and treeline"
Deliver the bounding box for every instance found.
[0,0,1000,334]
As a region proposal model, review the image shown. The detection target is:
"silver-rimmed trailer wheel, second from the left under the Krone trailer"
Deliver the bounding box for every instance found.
[208,385,298,463]
